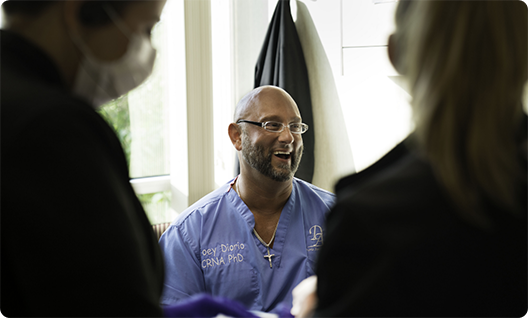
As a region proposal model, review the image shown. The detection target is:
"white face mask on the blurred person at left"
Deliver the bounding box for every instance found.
[72,6,156,108]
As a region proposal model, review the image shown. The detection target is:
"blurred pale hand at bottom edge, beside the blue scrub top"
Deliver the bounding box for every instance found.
[291,275,317,318]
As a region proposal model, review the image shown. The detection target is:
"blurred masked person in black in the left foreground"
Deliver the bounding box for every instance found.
[0,0,171,318]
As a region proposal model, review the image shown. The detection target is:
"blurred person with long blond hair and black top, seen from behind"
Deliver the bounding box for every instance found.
[305,0,528,318]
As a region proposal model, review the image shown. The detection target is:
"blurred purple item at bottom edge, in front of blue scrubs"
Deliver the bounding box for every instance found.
[163,294,258,318]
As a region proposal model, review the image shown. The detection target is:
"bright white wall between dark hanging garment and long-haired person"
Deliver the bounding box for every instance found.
[296,0,411,190]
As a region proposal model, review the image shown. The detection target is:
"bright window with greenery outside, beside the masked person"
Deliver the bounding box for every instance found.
[99,1,185,224]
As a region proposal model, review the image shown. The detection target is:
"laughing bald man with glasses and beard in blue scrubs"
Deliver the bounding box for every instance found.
[160,86,334,312]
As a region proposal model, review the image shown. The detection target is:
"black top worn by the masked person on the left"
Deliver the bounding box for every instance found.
[0,30,163,318]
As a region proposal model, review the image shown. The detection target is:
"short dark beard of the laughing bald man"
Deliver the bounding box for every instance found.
[242,136,304,182]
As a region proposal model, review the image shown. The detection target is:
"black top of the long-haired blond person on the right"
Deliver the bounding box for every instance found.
[315,132,528,318]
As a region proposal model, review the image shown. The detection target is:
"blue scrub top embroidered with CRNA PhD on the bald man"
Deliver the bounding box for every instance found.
[160,178,335,312]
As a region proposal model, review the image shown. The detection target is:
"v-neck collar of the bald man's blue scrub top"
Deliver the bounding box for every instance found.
[227,177,297,267]
